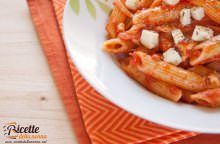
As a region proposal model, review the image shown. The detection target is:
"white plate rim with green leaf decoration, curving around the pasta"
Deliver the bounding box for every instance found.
[63,0,220,133]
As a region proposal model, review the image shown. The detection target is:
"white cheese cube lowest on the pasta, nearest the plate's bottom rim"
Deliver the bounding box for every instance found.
[163,48,182,65]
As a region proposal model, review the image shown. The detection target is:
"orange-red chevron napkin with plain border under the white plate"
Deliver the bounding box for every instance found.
[27,0,220,144]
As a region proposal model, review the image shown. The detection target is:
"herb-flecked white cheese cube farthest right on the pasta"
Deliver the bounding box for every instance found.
[192,25,214,41]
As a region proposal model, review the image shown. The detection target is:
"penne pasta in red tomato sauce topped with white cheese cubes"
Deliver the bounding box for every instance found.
[103,0,220,107]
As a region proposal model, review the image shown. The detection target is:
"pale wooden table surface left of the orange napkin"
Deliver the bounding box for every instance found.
[0,0,77,144]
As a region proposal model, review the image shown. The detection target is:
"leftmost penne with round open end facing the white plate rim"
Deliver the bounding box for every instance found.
[103,38,134,54]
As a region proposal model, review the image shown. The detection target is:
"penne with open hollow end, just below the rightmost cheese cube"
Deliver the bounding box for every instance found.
[190,35,220,66]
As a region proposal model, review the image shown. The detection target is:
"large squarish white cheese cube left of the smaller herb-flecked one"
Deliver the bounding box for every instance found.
[140,30,159,49]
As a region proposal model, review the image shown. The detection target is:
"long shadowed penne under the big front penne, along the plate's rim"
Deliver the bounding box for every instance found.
[121,58,182,102]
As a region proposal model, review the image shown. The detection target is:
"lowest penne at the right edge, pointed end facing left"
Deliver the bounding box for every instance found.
[191,88,220,107]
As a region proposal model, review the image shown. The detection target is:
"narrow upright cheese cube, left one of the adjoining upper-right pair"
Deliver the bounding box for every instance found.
[180,8,191,26]
